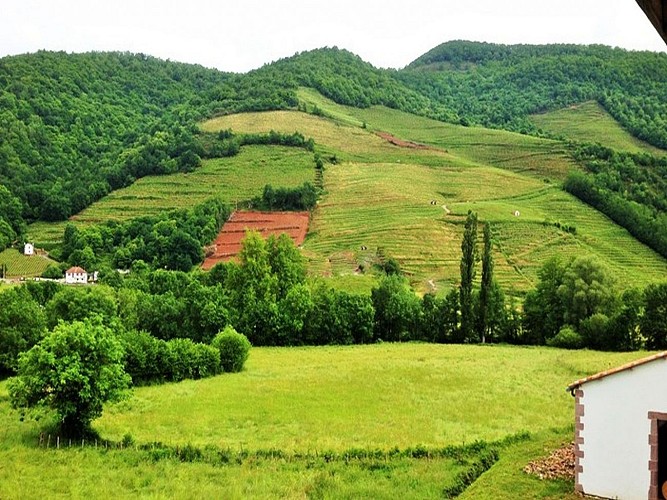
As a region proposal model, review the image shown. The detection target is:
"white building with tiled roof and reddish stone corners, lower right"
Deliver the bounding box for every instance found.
[568,351,667,500]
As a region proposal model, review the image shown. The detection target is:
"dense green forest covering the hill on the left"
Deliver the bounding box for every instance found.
[0,52,296,244]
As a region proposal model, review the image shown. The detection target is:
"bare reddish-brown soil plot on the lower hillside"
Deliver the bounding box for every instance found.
[202,211,309,270]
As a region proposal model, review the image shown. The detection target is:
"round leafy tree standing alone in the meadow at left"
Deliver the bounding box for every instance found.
[9,319,130,437]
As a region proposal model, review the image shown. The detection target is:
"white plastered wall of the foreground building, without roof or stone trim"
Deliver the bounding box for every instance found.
[579,359,667,500]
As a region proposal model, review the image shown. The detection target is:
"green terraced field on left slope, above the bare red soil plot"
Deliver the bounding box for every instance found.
[28,146,315,246]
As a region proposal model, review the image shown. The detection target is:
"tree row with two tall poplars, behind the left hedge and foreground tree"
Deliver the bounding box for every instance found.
[0,225,667,384]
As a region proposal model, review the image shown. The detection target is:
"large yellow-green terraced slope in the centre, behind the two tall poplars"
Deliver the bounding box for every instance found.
[203,91,667,292]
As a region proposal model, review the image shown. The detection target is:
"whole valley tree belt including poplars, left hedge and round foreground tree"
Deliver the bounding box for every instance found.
[5,223,667,436]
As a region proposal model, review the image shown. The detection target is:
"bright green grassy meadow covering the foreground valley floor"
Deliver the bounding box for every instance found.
[0,344,644,498]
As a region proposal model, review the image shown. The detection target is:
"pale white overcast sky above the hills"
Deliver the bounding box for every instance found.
[0,0,667,72]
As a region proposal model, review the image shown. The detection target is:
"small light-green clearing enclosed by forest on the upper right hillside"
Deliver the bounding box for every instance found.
[530,101,665,155]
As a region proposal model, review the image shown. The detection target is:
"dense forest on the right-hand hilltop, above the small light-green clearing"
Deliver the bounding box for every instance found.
[395,41,667,148]
